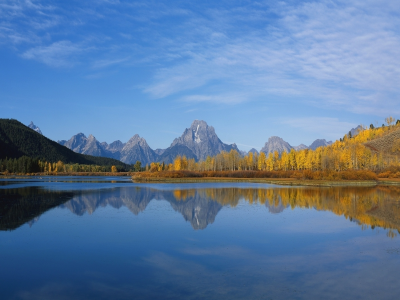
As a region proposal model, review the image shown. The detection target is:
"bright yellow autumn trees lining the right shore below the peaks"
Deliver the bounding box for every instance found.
[146,122,400,172]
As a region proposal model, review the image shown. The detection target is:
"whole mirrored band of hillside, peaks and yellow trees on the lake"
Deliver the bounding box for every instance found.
[0,186,400,237]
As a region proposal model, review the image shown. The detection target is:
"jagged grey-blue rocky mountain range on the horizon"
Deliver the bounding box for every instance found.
[51,120,332,165]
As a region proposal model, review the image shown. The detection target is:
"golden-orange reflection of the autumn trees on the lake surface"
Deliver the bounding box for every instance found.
[165,186,400,237]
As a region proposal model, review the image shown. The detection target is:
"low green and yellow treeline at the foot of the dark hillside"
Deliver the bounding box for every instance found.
[0,156,128,174]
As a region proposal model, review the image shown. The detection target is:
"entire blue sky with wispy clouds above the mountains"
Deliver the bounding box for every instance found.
[0,0,400,150]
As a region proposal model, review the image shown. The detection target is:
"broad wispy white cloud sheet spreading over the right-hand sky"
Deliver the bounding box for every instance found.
[144,1,400,115]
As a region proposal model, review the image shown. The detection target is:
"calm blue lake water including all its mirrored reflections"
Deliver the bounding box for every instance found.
[0,177,400,300]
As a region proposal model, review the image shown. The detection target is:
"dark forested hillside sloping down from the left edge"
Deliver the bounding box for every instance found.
[0,119,127,167]
